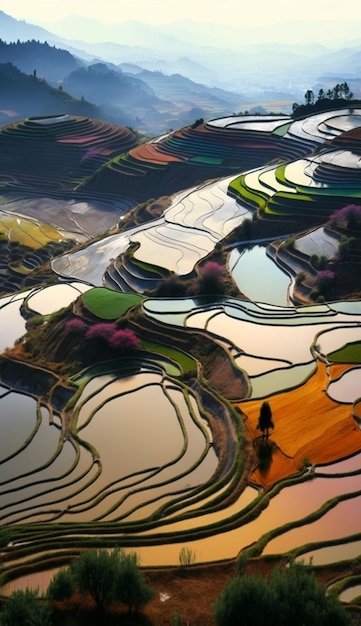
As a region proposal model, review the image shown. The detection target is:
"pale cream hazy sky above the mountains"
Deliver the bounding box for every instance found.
[0,0,361,28]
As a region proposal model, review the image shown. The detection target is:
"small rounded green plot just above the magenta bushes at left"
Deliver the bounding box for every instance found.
[83,287,143,320]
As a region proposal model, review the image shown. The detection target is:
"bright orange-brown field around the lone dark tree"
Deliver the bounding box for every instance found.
[233,362,361,487]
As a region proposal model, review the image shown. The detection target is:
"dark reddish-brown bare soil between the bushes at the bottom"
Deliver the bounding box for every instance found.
[48,558,361,626]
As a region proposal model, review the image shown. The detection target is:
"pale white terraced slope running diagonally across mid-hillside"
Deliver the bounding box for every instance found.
[53,178,250,284]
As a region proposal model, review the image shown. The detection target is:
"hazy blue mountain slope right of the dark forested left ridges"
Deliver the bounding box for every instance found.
[63,63,249,134]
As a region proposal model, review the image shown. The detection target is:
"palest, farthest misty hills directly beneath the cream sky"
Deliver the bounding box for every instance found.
[0,12,360,101]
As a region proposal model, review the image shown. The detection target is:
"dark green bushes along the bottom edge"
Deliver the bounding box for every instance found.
[0,550,352,626]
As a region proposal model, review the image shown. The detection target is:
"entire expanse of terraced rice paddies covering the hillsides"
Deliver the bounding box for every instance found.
[0,109,361,597]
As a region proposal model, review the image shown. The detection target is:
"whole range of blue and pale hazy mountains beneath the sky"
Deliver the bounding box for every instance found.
[0,11,361,134]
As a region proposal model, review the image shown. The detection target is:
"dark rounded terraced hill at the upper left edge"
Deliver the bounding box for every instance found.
[0,115,136,193]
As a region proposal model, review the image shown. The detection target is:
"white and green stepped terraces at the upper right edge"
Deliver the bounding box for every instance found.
[230,109,361,220]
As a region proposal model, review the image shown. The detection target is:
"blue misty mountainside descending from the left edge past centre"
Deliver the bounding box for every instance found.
[0,34,253,135]
